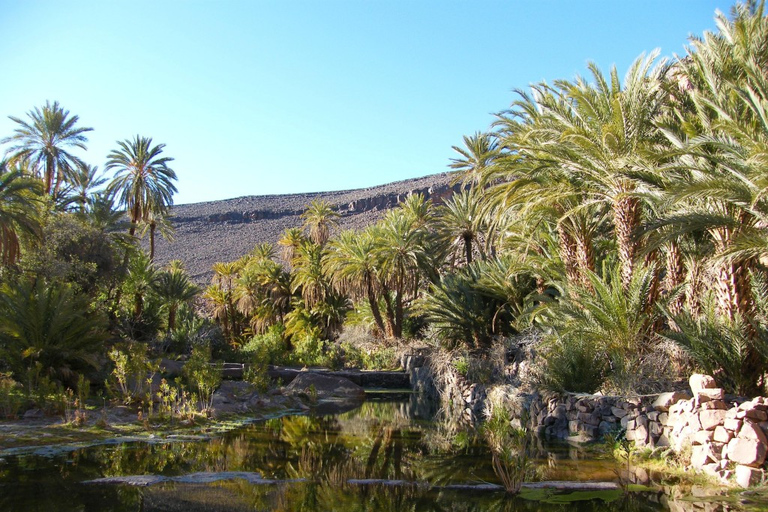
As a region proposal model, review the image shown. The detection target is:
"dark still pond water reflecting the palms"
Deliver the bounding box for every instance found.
[0,397,760,512]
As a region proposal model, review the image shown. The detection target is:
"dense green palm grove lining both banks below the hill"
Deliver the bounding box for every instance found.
[0,2,768,420]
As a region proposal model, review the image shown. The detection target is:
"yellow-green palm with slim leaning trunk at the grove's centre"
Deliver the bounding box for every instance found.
[323,228,386,334]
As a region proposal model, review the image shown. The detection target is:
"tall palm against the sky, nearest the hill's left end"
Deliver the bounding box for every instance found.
[106,135,176,236]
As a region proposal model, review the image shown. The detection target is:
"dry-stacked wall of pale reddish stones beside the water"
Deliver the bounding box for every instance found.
[529,375,768,487]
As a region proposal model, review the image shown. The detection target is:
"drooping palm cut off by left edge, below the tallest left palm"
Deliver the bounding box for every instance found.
[0,166,41,266]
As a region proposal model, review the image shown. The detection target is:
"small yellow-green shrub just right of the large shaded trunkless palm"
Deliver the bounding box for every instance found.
[107,341,160,404]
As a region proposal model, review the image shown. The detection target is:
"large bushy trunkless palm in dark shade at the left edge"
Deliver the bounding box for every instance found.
[0,279,107,386]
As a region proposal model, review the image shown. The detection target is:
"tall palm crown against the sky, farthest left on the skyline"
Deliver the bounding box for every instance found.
[0,101,93,196]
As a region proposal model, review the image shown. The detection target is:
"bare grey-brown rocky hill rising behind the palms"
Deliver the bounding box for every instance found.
[153,173,458,284]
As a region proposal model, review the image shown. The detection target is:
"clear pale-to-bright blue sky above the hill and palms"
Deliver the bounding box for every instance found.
[0,0,733,204]
